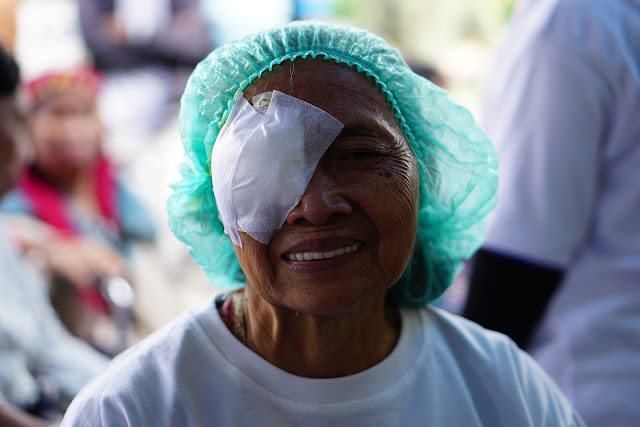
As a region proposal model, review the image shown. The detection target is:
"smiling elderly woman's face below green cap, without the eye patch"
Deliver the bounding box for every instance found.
[235,60,418,314]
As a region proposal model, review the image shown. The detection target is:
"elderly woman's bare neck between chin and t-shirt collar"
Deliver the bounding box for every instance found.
[245,287,400,378]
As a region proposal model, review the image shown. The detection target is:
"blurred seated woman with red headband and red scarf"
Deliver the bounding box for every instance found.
[2,68,154,352]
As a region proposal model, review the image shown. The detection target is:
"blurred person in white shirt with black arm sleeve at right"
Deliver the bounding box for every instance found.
[464,0,640,427]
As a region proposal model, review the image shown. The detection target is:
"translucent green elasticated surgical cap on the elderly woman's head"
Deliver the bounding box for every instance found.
[167,21,498,307]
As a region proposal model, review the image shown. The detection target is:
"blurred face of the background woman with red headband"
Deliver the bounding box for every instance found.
[31,90,102,180]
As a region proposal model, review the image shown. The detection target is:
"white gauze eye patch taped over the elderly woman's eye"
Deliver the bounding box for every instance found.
[211,91,344,246]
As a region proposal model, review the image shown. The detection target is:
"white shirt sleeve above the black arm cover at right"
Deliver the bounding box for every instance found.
[484,32,608,267]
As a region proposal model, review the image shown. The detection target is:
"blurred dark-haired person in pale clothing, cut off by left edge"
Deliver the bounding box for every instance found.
[0,48,108,426]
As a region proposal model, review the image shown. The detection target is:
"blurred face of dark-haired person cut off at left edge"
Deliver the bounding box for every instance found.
[0,95,30,197]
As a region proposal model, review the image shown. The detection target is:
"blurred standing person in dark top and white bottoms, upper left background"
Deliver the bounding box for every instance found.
[78,0,212,132]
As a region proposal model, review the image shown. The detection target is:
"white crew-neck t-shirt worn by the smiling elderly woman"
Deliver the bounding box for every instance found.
[62,294,583,427]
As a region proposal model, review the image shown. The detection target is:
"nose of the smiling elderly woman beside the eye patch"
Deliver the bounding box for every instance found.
[287,168,352,225]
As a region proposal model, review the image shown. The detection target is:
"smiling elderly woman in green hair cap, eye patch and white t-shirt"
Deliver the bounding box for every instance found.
[63,22,582,426]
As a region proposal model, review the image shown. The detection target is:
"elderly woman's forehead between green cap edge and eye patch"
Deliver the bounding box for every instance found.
[245,59,399,129]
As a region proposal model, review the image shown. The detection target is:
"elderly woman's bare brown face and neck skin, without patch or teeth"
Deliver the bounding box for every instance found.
[230,60,418,378]
